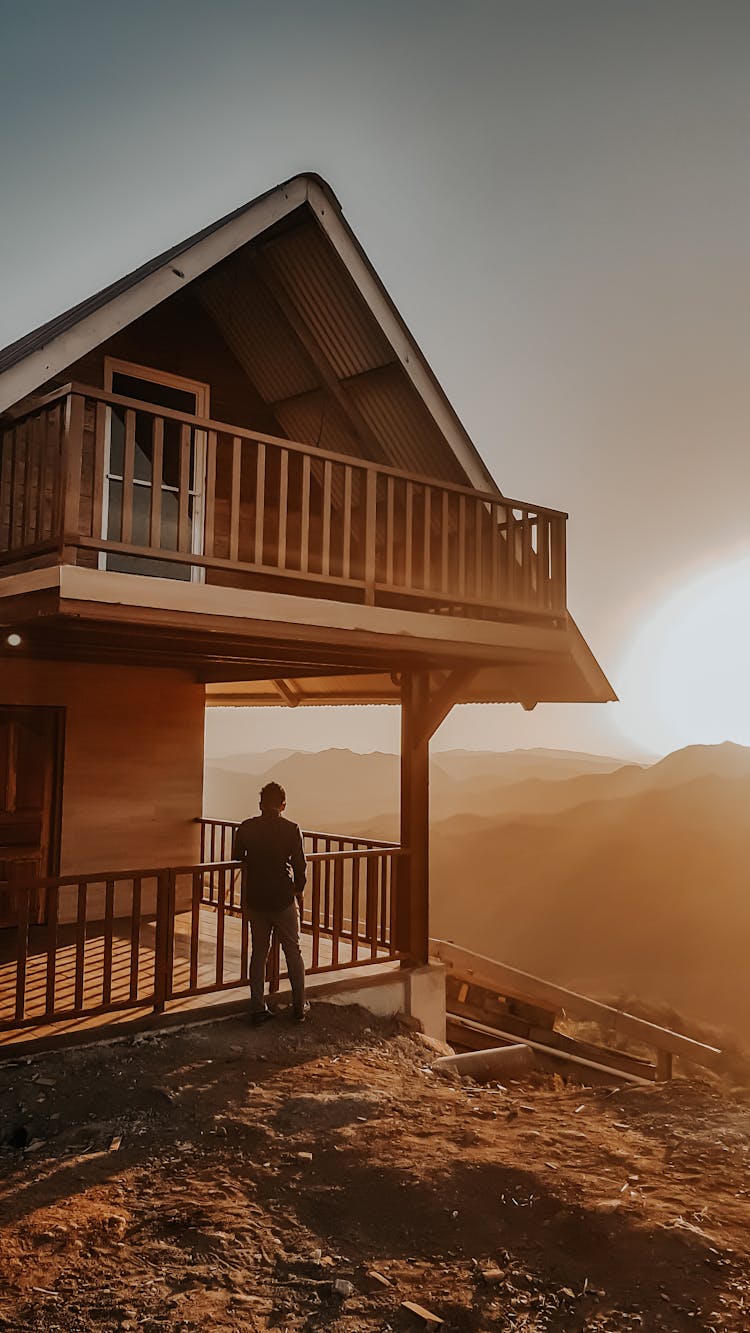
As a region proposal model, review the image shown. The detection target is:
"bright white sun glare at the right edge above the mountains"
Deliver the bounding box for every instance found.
[615,556,750,753]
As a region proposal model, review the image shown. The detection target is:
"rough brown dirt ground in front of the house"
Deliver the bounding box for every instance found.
[0,1005,750,1333]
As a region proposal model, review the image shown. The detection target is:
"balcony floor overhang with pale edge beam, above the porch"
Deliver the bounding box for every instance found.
[0,565,615,708]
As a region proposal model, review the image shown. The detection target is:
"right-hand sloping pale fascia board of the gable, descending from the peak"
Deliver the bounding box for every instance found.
[308,180,498,491]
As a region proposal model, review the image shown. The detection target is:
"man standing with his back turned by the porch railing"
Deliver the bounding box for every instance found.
[232,782,310,1024]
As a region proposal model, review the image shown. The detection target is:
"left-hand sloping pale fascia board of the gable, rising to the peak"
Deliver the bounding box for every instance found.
[0,176,308,412]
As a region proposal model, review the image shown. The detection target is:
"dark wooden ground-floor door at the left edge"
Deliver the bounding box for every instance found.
[0,706,61,926]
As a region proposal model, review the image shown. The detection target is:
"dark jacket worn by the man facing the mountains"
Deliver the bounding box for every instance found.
[232,810,306,912]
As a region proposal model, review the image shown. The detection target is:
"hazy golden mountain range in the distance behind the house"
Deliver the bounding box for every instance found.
[205,742,750,1041]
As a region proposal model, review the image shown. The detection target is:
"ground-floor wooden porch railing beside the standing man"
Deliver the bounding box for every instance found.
[0,834,404,1030]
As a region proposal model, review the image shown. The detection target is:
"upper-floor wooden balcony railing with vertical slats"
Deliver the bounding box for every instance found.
[0,384,566,617]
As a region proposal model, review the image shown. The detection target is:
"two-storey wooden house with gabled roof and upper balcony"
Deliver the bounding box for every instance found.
[0,176,614,1025]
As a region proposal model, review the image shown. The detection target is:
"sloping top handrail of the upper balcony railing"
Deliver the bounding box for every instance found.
[15,380,567,519]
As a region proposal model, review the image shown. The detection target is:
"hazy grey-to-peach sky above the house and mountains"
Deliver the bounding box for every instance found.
[0,0,750,750]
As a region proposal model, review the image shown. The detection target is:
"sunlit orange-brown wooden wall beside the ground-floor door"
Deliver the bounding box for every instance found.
[0,661,204,874]
